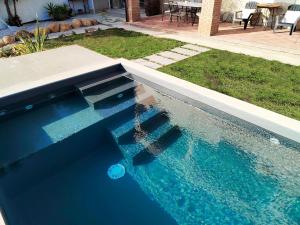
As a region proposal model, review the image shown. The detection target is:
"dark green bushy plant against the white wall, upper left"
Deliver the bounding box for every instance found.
[45,2,72,21]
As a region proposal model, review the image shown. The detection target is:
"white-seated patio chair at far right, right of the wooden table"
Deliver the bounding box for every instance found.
[273,5,300,35]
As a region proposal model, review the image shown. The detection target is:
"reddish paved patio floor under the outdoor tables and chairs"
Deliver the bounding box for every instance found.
[132,15,300,54]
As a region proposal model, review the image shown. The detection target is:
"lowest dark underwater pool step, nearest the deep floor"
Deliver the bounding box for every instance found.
[133,125,182,166]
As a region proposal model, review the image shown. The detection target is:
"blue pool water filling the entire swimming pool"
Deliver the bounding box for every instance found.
[0,76,300,225]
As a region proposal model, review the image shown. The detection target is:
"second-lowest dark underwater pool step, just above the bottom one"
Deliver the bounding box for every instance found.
[118,111,170,144]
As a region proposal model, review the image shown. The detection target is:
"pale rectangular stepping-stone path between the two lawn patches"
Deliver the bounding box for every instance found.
[134,44,209,69]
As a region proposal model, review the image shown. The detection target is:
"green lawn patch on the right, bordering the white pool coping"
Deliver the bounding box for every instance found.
[160,50,300,120]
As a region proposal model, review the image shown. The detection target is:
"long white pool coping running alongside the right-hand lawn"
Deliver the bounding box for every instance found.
[119,59,300,143]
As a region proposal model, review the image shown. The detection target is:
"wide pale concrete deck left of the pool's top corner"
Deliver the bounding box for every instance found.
[0,45,116,98]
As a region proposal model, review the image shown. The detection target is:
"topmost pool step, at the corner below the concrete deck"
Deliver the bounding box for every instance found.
[76,71,129,95]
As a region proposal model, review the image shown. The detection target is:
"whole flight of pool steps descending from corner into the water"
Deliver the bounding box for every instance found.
[77,72,182,165]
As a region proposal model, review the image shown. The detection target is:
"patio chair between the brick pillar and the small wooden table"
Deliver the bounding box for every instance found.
[232,1,260,30]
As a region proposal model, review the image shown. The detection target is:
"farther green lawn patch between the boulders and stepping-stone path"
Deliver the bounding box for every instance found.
[45,28,184,59]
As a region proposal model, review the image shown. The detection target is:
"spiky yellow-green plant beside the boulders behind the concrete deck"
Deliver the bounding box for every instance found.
[18,20,47,53]
